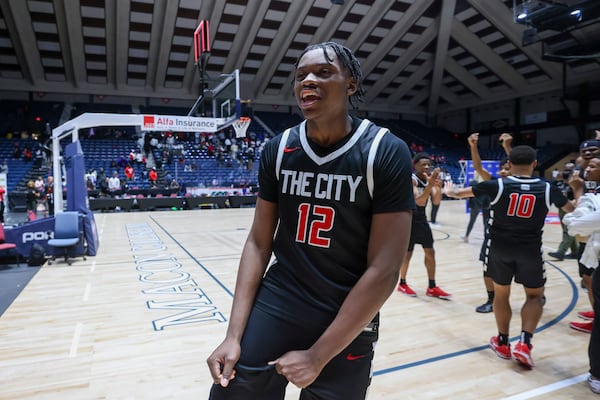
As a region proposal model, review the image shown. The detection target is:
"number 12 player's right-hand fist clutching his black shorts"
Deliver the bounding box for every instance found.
[269,350,324,388]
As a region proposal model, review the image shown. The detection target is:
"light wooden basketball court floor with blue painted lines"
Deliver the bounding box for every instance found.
[0,200,593,400]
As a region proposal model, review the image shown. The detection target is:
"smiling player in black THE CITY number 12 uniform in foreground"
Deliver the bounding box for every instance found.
[207,42,414,400]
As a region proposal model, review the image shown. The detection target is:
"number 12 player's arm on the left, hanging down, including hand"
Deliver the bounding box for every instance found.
[207,197,278,386]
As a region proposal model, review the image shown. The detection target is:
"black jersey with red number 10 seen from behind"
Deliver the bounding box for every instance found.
[473,176,568,245]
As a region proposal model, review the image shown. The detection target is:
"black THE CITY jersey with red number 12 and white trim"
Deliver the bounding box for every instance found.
[257,119,414,323]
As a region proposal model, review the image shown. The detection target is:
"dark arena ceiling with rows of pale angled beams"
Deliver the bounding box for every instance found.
[0,0,600,116]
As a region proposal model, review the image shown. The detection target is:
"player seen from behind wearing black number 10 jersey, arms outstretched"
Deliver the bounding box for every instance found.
[445,146,574,368]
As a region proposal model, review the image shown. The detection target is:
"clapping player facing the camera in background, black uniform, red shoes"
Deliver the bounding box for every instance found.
[398,153,452,300]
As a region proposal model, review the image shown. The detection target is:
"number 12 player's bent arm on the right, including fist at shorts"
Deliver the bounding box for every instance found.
[270,211,412,388]
